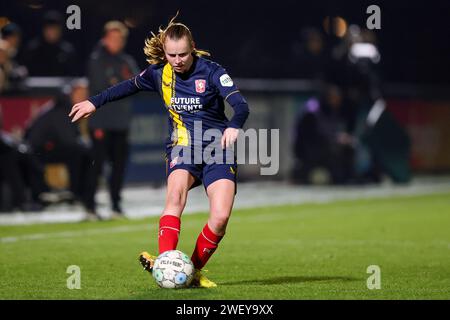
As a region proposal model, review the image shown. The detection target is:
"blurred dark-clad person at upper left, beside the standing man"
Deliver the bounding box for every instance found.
[23,11,80,77]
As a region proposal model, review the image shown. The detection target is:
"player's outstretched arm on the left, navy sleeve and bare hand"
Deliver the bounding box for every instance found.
[69,66,156,122]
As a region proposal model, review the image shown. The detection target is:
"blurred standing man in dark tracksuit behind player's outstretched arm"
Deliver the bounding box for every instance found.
[88,21,139,215]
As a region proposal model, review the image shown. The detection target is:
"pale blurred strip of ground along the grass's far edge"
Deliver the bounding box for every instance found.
[0,177,450,225]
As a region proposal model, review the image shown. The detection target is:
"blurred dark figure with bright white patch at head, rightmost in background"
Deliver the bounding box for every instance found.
[329,25,410,183]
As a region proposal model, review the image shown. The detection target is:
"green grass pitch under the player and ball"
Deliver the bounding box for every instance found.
[0,194,450,300]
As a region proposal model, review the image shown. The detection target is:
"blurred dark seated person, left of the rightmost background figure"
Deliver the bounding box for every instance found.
[294,84,355,184]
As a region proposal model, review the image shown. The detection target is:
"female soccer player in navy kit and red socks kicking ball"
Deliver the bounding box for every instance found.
[69,16,249,287]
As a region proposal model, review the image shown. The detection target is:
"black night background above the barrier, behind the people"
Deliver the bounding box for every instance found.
[0,0,450,84]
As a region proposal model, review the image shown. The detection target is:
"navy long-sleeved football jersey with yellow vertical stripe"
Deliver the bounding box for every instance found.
[89,57,249,146]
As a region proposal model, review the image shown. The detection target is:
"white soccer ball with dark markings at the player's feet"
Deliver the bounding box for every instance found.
[152,250,194,289]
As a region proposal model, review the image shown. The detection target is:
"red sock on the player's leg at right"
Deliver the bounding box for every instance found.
[191,224,223,270]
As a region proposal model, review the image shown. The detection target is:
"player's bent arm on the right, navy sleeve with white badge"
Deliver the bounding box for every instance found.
[212,67,250,148]
